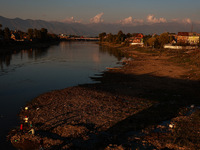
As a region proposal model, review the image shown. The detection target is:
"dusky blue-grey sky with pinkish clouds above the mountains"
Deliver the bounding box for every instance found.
[0,0,200,24]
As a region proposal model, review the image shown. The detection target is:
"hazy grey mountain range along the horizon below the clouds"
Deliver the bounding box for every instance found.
[0,16,200,36]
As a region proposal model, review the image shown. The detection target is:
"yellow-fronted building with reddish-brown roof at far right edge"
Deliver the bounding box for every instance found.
[177,32,199,45]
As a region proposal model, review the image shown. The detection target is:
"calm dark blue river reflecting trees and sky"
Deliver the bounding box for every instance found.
[0,42,123,147]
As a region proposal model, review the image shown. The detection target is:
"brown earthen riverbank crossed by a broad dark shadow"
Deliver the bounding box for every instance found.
[7,42,200,149]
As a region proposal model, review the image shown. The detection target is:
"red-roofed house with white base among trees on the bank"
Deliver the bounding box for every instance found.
[128,33,144,46]
